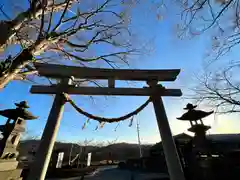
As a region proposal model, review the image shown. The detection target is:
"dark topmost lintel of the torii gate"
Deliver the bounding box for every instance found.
[34,63,180,81]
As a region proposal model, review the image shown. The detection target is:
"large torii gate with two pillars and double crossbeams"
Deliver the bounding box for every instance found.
[28,63,185,180]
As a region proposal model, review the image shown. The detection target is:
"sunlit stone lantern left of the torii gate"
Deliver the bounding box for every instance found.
[0,101,37,180]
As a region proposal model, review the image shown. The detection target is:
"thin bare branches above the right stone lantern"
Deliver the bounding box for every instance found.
[189,63,240,114]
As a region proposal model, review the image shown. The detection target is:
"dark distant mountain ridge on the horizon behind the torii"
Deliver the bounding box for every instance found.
[18,140,151,161]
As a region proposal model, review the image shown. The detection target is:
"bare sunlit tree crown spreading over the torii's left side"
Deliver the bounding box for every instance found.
[0,0,140,88]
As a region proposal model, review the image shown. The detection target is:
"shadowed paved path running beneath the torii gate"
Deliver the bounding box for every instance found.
[48,167,166,180]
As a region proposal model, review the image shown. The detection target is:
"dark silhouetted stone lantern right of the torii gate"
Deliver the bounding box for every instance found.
[177,104,213,180]
